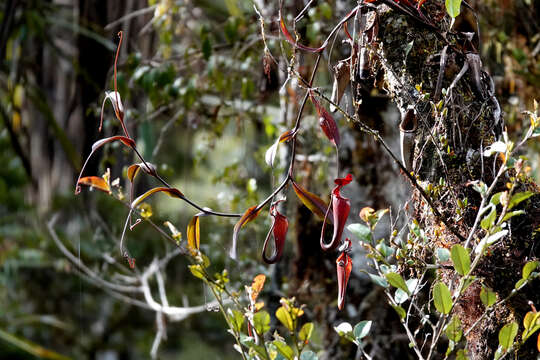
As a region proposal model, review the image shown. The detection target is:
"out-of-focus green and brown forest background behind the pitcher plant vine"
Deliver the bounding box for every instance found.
[0,0,540,359]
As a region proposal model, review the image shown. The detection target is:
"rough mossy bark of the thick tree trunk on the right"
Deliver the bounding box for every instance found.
[350,1,540,359]
